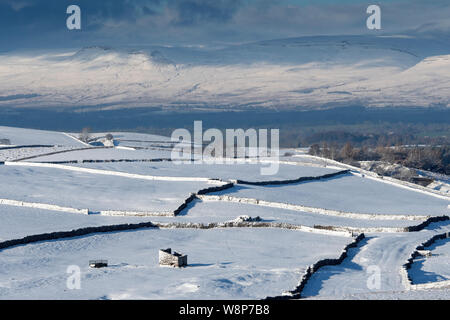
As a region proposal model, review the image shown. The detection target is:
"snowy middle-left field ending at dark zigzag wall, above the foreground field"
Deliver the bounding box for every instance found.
[0,166,210,211]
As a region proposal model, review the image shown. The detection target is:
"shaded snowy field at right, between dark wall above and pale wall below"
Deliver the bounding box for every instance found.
[211,175,449,216]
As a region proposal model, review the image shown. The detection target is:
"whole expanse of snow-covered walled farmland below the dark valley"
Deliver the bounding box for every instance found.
[0,127,450,299]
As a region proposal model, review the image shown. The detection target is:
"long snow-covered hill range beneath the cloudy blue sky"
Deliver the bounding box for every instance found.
[0,36,450,108]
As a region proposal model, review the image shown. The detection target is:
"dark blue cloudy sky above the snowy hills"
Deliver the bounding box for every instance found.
[0,0,450,52]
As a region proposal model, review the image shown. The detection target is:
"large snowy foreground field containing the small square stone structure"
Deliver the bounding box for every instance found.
[0,228,352,299]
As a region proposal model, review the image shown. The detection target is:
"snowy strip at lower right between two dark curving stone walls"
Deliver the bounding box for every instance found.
[304,221,450,299]
